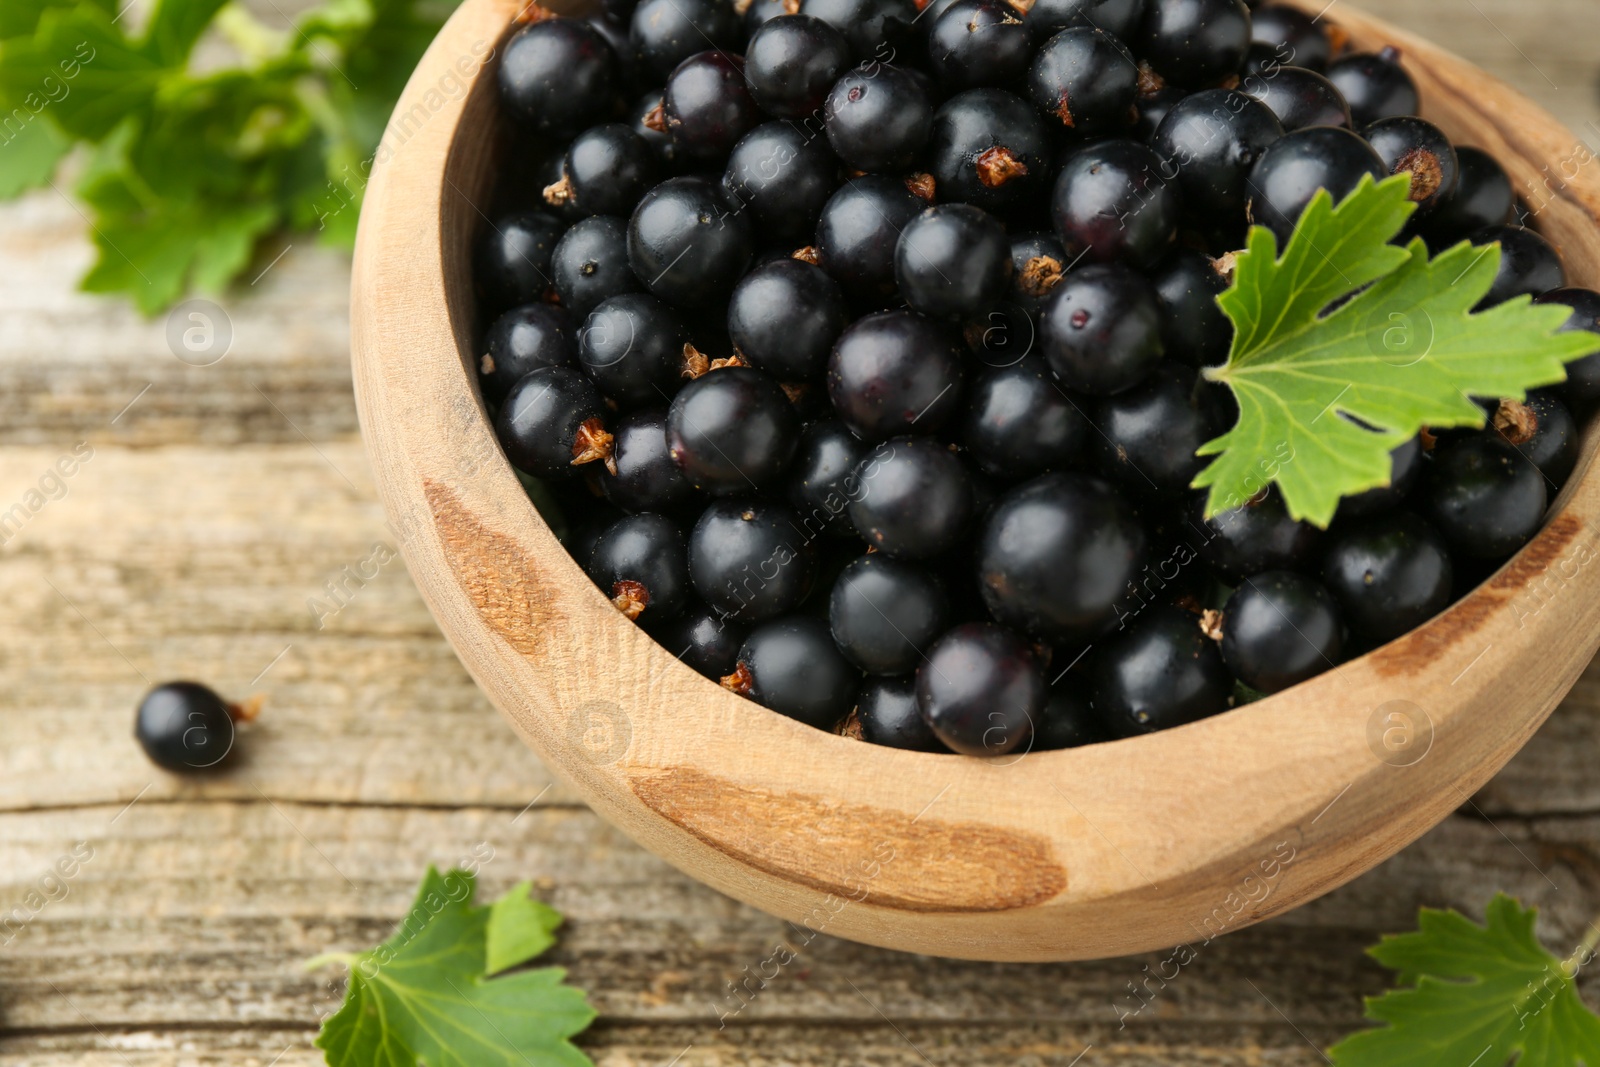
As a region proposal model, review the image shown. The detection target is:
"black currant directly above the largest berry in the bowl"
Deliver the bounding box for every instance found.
[958,355,1091,482]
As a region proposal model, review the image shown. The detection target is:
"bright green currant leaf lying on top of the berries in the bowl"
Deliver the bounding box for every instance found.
[1194,174,1600,526]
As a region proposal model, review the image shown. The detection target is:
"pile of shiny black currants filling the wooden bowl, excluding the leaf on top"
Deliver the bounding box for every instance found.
[475,0,1600,755]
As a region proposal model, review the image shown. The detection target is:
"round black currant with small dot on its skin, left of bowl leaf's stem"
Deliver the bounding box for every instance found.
[1038,264,1163,397]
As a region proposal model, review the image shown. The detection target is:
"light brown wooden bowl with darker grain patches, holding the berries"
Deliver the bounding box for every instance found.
[354,0,1600,960]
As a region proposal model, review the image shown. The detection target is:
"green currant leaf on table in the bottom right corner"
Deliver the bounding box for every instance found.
[1328,894,1600,1067]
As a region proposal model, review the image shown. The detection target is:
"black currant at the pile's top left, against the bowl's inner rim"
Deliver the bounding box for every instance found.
[496,19,621,138]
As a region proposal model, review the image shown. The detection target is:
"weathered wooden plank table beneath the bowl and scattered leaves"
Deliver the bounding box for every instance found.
[0,0,1600,1067]
